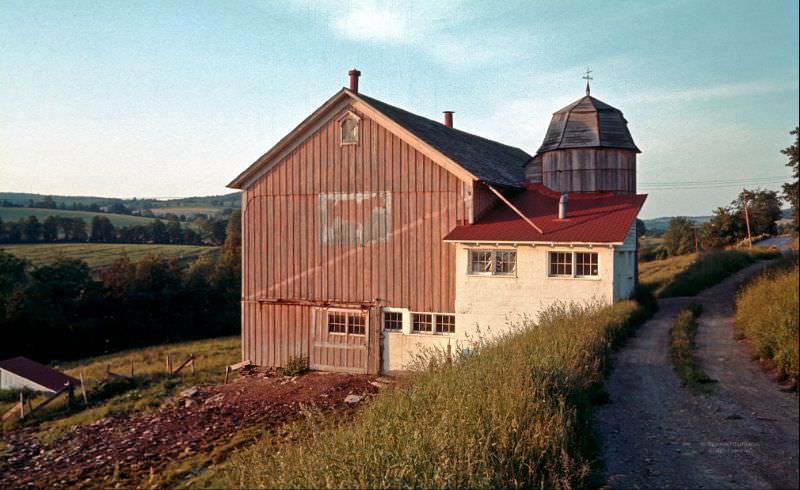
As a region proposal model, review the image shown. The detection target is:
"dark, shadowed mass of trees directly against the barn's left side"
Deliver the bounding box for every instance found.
[0,212,241,362]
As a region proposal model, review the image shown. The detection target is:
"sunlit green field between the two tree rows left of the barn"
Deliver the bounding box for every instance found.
[0,243,218,268]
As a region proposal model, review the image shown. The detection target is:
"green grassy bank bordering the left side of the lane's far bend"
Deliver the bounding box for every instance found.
[657,248,780,298]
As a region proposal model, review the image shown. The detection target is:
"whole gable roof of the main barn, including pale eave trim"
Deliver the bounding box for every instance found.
[228,88,532,189]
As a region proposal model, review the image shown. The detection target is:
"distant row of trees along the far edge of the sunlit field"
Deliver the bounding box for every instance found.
[0,215,228,245]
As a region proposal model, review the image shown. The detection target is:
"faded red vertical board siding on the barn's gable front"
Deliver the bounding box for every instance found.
[242,105,471,366]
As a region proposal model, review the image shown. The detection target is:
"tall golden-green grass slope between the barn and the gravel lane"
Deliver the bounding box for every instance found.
[223,301,648,488]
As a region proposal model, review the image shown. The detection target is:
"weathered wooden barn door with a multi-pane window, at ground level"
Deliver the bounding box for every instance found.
[309,307,371,373]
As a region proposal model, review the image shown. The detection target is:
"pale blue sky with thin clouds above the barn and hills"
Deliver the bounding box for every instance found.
[0,0,800,218]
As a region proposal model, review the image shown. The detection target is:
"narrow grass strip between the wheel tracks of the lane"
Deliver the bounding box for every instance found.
[669,304,714,393]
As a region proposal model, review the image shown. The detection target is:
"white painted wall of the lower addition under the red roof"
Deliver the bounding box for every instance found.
[381,226,636,371]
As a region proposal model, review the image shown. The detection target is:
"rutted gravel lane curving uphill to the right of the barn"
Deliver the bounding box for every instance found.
[595,264,800,488]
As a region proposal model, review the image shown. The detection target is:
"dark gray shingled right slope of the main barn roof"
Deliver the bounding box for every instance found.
[354,93,532,187]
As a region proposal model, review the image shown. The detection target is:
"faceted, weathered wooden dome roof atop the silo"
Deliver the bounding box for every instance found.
[536,95,641,154]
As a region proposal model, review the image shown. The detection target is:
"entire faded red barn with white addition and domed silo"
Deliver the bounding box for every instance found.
[229,69,646,373]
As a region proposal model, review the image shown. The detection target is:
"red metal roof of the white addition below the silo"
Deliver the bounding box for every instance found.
[444,184,647,243]
